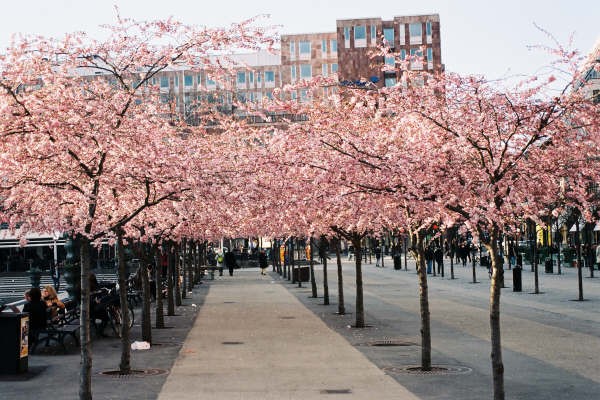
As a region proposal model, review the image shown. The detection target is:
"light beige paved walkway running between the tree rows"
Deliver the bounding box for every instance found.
[158,270,418,400]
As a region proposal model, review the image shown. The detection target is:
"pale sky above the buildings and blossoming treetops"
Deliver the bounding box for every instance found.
[0,0,600,79]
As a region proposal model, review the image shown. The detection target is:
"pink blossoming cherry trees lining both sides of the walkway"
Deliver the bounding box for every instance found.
[0,14,600,399]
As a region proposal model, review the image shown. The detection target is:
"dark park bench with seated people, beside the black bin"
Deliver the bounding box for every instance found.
[30,299,80,354]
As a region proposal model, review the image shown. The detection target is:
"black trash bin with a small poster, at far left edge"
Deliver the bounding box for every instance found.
[0,313,29,374]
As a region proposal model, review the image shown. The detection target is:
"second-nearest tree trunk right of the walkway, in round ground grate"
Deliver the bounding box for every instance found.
[413,232,431,371]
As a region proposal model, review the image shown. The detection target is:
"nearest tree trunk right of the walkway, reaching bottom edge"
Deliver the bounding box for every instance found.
[486,228,504,400]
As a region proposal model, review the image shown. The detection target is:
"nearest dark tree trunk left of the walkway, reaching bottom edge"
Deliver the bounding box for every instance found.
[79,237,92,400]
